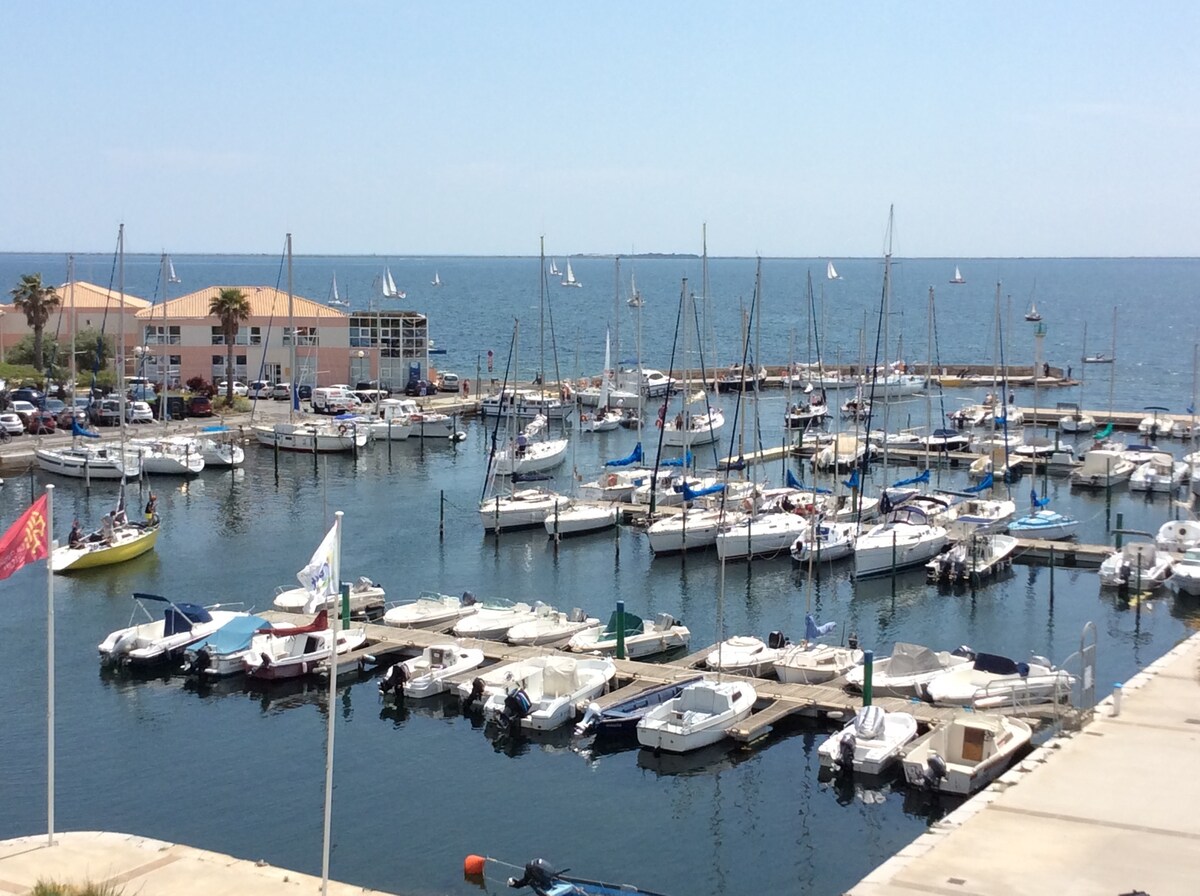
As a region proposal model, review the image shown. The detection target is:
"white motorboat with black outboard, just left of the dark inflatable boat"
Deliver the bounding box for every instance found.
[458,655,617,730]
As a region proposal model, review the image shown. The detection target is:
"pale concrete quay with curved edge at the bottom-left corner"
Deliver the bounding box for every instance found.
[0,831,398,896]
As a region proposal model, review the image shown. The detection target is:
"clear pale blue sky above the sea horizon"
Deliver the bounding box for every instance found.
[9,0,1200,258]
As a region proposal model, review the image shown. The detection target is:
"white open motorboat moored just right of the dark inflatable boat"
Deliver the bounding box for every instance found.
[637,679,758,753]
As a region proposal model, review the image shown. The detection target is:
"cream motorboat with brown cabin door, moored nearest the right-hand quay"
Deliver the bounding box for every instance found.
[904,712,1033,795]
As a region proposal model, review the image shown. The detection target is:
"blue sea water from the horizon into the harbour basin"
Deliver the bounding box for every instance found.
[0,254,1200,896]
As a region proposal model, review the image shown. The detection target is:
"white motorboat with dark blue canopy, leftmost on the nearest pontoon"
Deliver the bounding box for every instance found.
[98,591,246,666]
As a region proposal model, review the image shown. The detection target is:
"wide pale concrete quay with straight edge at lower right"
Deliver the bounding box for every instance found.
[847,635,1200,896]
